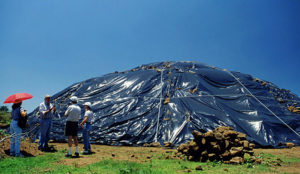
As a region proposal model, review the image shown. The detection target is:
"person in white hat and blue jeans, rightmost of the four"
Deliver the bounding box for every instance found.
[80,102,93,155]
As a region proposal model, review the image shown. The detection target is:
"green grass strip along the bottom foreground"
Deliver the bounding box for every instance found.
[0,151,300,174]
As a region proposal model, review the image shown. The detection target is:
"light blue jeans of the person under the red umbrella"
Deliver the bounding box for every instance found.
[10,120,22,156]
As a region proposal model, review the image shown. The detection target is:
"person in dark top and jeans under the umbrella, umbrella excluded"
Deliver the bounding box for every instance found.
[10,101,27,157]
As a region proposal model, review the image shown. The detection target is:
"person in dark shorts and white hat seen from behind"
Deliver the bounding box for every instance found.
[65,96,81,157]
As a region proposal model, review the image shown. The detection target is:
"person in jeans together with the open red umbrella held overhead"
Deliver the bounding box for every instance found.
[4,93,33,157]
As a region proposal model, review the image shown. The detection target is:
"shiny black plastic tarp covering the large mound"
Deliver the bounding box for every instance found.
[29,62,300,147]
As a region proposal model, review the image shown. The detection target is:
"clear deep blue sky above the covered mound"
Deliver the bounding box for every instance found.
[0,0,300,111]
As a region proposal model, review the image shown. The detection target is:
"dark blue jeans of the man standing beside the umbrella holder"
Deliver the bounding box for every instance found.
[39,118,52,149]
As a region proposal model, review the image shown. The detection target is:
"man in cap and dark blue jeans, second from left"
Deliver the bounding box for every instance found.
[38,95,56,151]
